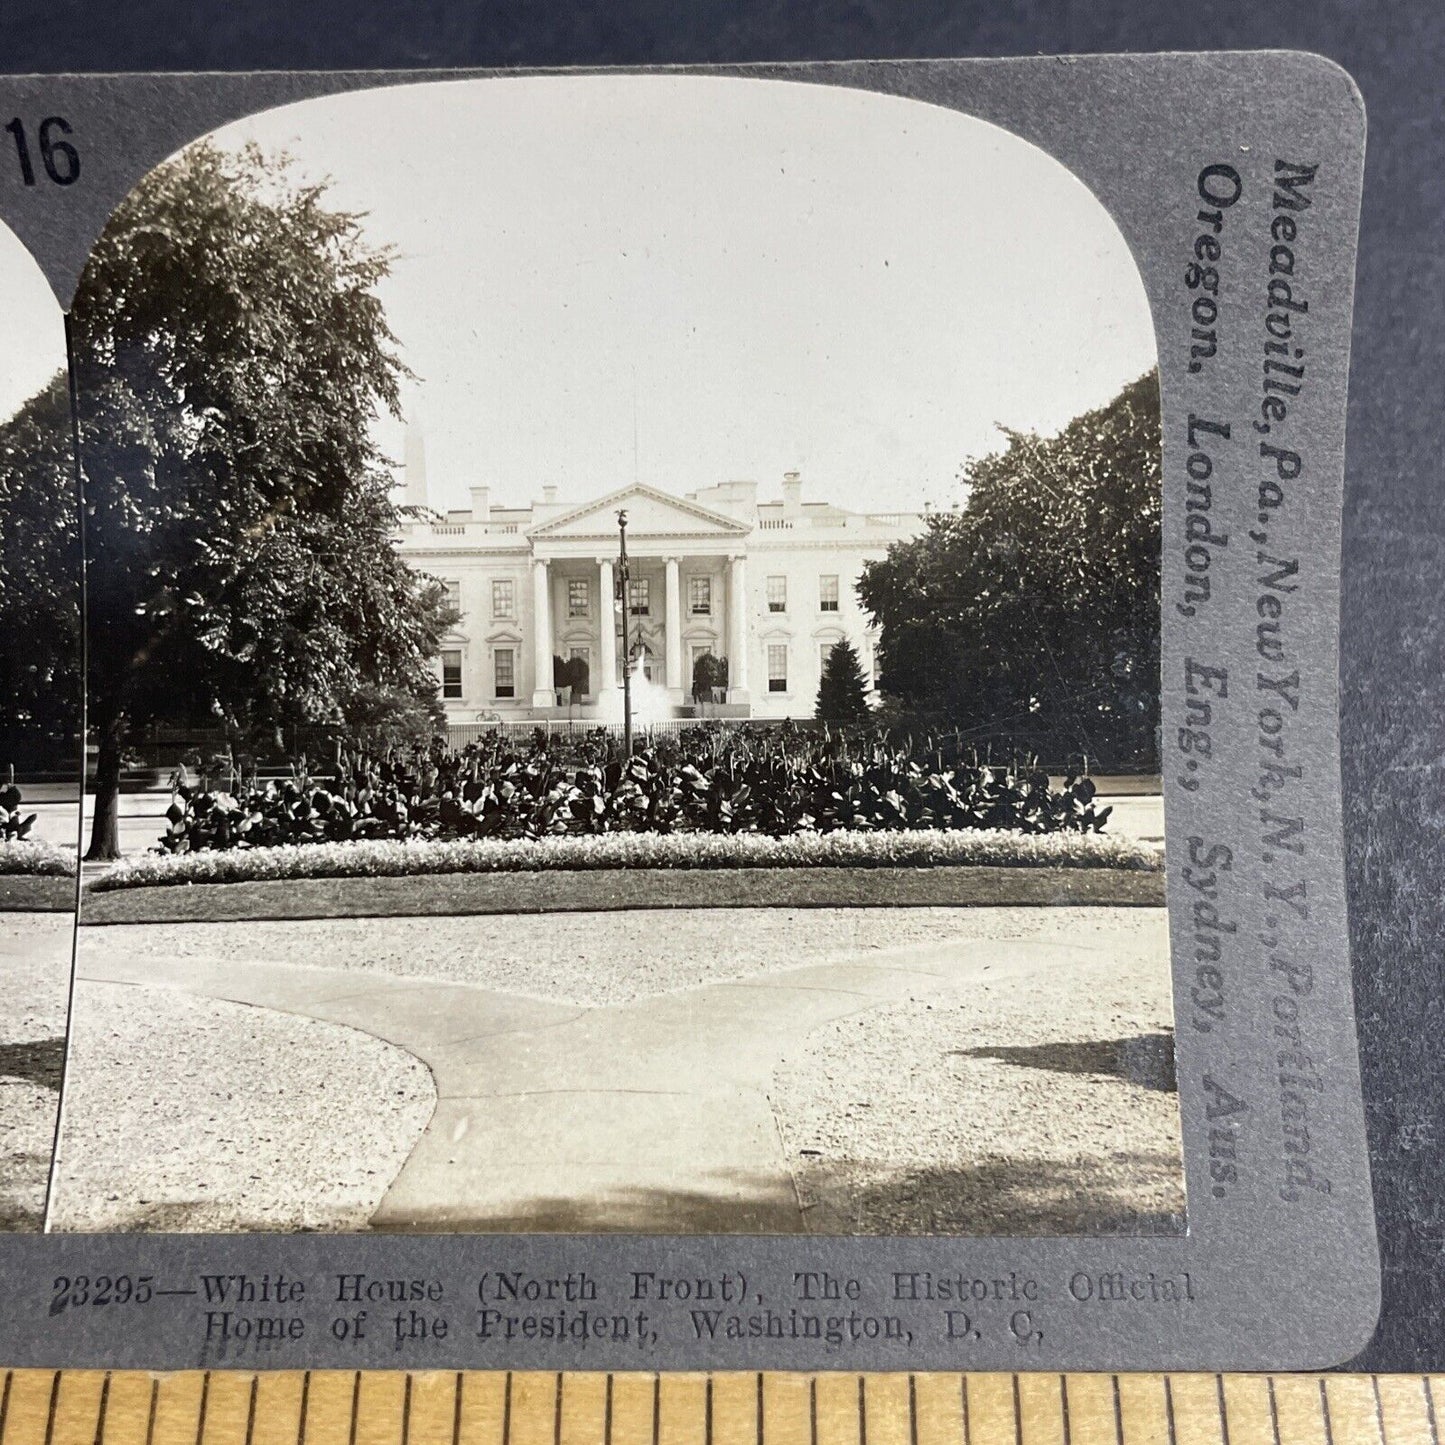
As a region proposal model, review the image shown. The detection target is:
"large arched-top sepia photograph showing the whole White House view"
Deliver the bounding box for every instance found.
[16,74,1185,1235]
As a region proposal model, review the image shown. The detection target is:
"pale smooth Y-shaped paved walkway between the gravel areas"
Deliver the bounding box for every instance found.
[68,910,1176,1233]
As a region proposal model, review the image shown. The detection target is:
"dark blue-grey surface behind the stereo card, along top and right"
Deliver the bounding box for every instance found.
[0,0,1445,1370]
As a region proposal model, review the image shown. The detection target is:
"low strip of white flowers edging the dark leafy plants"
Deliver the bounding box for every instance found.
[90,828,1163,892]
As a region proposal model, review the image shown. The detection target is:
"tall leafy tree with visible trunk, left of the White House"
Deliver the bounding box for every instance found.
[72,142,451,858]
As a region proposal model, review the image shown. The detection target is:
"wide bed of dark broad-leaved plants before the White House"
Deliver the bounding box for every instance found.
[152,724,1110,853]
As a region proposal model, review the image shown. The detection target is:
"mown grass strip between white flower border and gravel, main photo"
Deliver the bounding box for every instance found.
[81,867,1165,923]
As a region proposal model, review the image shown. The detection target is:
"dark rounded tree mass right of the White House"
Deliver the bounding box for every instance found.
[858,373,1162,766]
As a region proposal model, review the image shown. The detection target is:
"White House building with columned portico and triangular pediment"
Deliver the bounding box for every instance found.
[399,438,922,725]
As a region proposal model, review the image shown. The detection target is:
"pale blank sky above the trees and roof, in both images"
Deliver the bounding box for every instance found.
[0,77,1155,509]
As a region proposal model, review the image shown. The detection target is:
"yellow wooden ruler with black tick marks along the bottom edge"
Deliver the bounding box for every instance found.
[0,1370,1445,1445]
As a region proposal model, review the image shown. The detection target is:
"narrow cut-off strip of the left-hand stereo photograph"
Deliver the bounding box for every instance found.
[0,225,82,1233]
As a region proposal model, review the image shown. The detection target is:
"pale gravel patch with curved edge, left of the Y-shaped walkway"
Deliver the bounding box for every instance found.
[49,981,436,1234]
